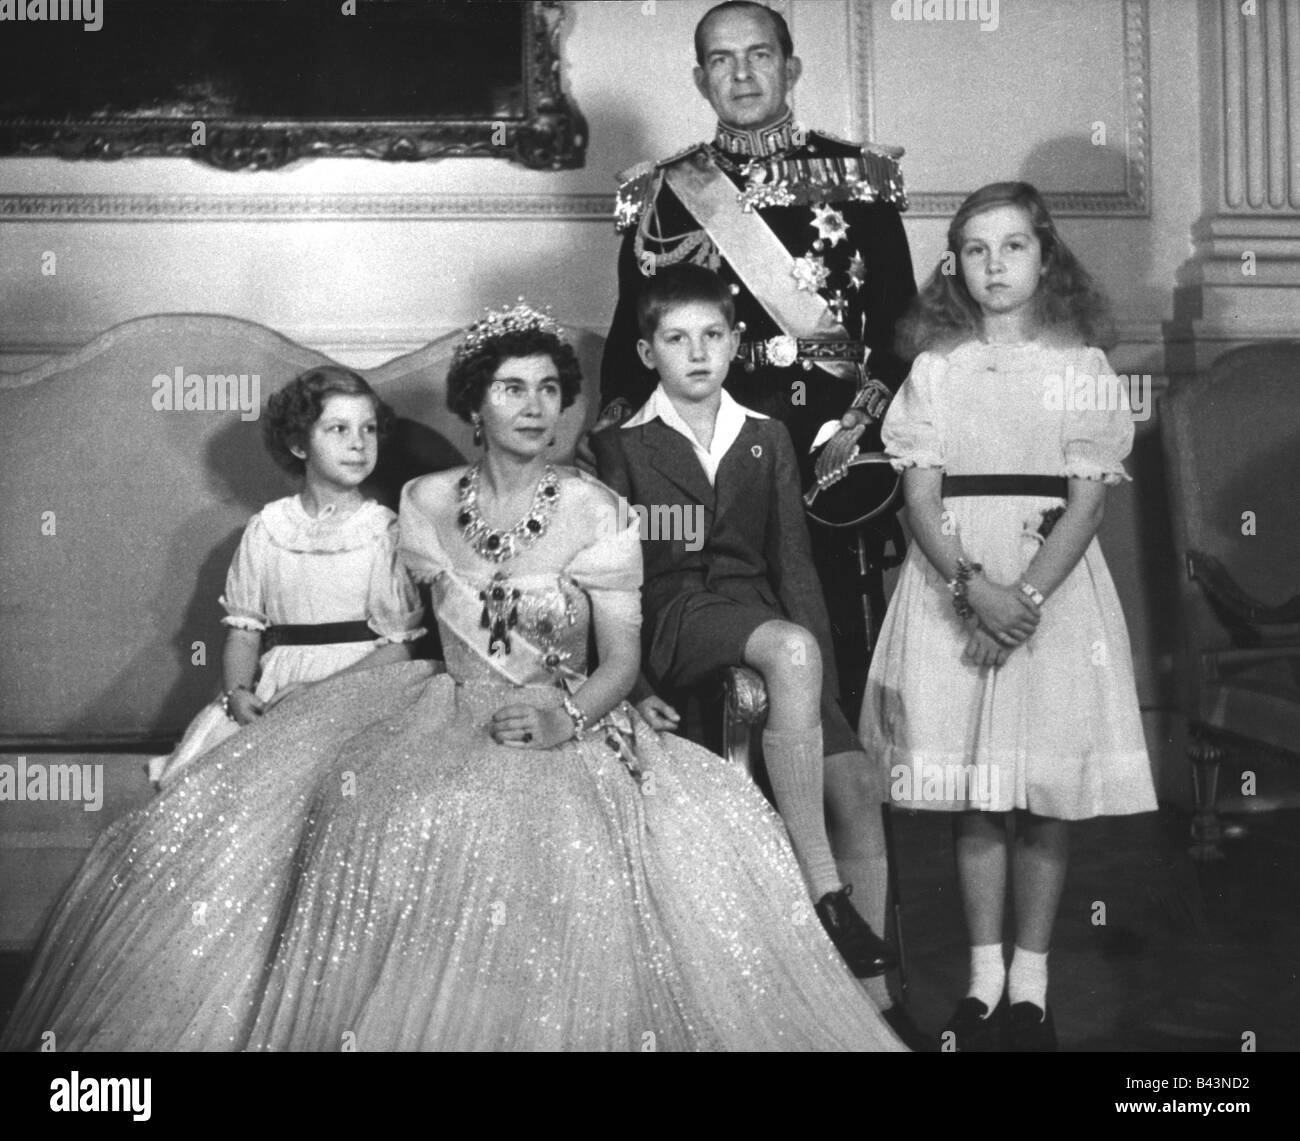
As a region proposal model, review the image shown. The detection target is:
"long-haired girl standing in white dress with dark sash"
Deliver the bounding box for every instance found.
[859,182,1156,1050]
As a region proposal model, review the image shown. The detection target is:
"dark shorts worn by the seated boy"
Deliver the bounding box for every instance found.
[660,594,862,756]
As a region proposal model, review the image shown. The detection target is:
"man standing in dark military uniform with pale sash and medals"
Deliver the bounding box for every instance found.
[594,0,917,1041]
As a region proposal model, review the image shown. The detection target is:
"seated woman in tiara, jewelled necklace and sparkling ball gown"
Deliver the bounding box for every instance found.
[4,307,904,1050]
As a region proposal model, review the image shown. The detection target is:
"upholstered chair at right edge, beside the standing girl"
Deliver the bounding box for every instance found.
[1161,342,1300,859]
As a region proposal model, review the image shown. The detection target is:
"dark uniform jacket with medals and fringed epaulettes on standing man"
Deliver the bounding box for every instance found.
[601,116,917,467]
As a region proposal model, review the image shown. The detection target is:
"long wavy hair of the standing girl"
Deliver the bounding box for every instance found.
[897,182,1114,359]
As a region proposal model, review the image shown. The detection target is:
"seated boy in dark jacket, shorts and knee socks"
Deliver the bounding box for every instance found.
[592,264,894,992]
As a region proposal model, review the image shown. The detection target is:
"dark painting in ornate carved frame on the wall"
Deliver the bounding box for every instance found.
[0,0,586,170]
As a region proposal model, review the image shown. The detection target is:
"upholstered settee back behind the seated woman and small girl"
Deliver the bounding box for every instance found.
[0,314,601,749]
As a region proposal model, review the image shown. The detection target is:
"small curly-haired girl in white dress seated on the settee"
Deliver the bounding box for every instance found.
[150,365,424,788]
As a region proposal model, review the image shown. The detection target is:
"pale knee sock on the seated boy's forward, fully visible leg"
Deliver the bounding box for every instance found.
[763,725,842,902]
